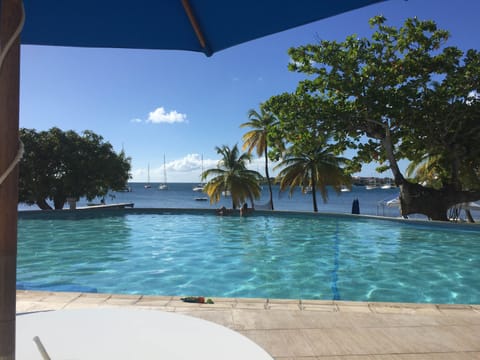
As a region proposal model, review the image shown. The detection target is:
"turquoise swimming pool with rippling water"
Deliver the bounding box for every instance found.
[17,209,480,304]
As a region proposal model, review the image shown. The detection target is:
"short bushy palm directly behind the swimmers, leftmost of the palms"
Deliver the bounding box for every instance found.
[202,145,262,209]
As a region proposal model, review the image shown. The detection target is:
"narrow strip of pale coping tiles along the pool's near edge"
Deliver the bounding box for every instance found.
[16,290,480,315]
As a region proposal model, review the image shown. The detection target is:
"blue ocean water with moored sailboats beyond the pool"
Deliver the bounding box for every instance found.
[19,183,400,217]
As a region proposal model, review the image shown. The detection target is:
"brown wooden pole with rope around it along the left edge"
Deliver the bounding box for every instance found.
[0,0,22,360]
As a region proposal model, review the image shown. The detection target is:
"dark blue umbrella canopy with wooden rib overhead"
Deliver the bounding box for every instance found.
[21,0,383,56]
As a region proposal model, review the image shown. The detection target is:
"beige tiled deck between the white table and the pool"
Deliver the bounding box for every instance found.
[17,291,480,360]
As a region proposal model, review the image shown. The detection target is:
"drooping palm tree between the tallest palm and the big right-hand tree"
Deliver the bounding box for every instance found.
[275,146,351,212]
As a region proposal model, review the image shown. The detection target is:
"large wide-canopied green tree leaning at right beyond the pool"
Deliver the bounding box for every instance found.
[289,16,480,220]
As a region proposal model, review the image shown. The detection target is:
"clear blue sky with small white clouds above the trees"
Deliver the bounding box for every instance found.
[20,0,480,182]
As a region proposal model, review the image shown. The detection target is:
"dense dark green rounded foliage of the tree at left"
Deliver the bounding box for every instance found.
[19,128,130,209]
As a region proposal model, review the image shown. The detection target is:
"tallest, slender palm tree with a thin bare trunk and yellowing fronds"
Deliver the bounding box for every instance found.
[240,108,277,210]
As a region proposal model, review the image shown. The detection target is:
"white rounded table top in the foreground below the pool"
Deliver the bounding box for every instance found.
[16,308,272,360]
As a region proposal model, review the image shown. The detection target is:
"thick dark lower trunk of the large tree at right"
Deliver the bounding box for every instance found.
[400,180,480,221]
